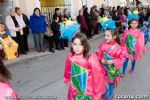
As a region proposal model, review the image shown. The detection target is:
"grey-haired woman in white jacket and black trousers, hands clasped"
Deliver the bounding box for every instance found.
[6,8,27,54]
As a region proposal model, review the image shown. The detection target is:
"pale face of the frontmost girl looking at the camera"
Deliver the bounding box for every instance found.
[72,38,84,54]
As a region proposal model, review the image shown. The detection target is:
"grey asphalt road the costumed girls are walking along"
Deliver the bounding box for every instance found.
[6,35,150,100]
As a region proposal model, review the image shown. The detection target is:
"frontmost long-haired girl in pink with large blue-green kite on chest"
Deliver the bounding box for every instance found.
[64,33,106,100]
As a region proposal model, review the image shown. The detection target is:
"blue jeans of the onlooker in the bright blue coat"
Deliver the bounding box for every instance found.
[33,33,44,51]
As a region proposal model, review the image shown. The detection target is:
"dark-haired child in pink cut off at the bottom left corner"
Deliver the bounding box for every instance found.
[0,59,20,100]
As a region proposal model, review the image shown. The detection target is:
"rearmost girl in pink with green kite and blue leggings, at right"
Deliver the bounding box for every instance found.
[121,19,146,77]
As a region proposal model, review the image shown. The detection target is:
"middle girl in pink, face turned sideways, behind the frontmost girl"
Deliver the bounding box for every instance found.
[96,29,125,100]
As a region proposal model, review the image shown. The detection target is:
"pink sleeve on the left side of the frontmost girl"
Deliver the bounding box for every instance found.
[64,54,71,83]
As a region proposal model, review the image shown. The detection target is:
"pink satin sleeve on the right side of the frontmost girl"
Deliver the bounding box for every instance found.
[89,54,106,100]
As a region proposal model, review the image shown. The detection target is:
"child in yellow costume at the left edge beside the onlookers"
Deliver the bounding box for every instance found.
[0,23,18,60]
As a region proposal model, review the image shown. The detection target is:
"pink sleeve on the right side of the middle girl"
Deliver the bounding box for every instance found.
[113,46,125,69]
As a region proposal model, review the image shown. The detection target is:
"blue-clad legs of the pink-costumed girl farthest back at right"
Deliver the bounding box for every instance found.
[122,58,136,74]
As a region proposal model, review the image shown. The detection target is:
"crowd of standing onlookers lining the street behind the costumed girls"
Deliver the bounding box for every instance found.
[0,5,150,59]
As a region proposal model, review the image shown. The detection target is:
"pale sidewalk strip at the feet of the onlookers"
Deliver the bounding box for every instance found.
[4,33,103,66]
